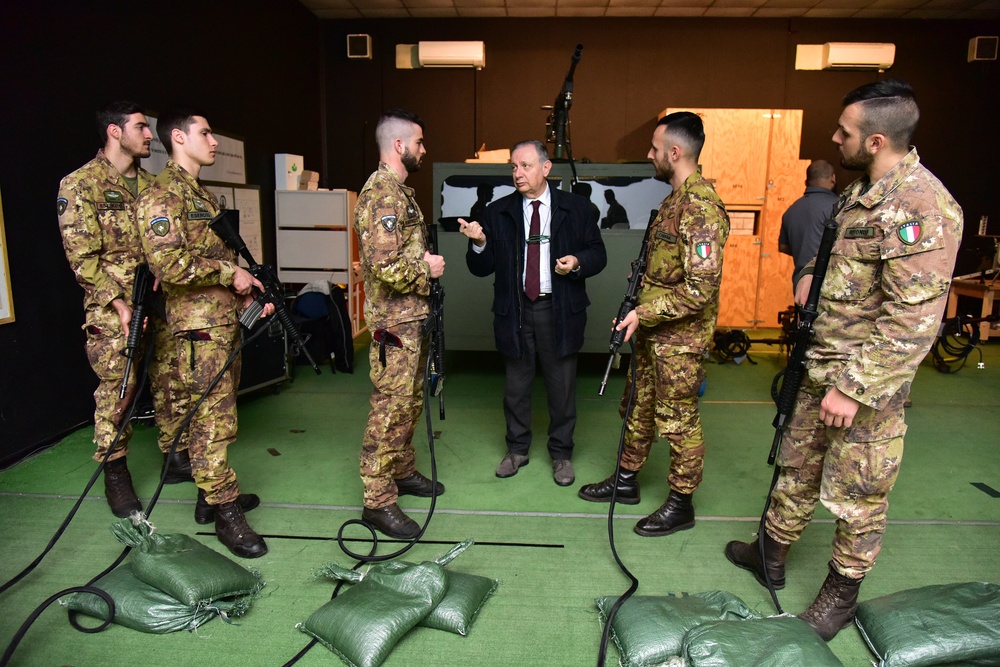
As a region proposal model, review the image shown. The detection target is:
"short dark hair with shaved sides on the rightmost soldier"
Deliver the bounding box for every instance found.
[844,79,920,149]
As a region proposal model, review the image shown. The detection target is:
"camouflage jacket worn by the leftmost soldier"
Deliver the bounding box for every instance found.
[56,150,153,332]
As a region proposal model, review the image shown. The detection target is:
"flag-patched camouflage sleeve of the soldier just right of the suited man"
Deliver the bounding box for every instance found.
[635,201,726,327]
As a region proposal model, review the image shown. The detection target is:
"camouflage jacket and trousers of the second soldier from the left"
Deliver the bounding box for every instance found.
[136,160,241,505]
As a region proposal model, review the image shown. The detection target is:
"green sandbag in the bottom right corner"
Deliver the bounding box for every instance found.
[855,582,1000,667]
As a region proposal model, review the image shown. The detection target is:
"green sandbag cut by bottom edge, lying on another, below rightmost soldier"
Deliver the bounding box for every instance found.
[683,616,844,667]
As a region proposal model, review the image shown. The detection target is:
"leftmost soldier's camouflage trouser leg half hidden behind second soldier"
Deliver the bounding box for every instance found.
[147,315,192,454]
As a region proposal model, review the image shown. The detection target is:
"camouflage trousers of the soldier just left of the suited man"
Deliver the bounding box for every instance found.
[361,322,427,509]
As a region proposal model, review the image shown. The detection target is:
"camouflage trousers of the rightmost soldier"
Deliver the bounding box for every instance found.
[766,380,906,578]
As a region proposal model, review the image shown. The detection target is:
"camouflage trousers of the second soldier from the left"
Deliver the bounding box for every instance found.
[174,326,240,505]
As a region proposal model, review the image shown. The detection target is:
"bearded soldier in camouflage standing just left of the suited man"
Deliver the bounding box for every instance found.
[354,109,444,539]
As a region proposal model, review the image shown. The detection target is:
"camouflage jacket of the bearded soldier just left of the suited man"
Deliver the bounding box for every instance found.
[354,163,431,330]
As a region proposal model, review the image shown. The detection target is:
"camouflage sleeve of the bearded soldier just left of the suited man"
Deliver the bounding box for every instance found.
[358,196,431,296]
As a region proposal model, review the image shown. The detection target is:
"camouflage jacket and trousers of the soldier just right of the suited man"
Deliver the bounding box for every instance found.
[620,171,729,494]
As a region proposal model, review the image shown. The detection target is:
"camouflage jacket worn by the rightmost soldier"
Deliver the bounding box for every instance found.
[807,149,963,410]
